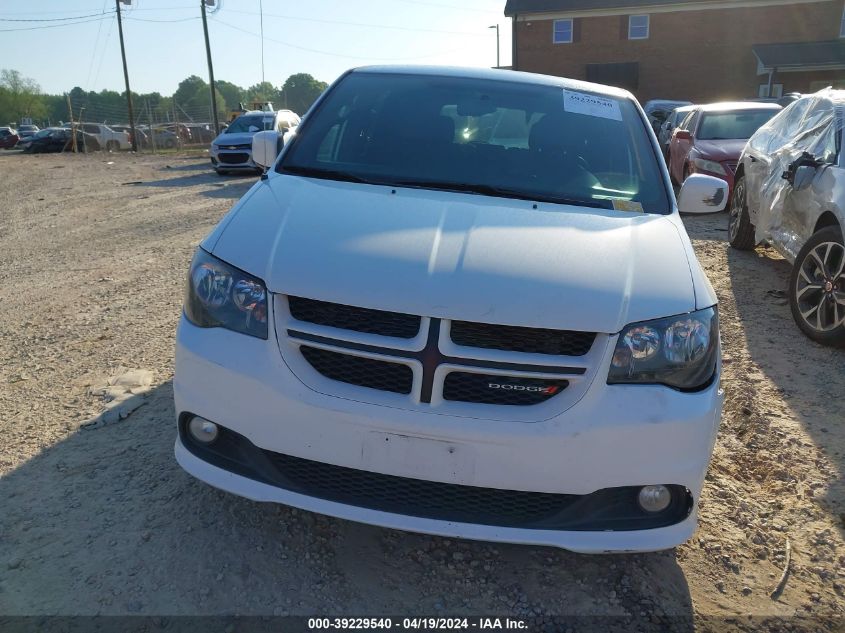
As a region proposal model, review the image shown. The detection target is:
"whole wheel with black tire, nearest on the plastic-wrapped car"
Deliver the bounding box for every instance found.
[789,226,845,348]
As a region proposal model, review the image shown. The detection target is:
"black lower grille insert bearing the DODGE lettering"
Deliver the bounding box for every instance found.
[443,371,569,406]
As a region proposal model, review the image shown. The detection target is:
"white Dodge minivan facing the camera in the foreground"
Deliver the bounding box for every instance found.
[174,67,727,552]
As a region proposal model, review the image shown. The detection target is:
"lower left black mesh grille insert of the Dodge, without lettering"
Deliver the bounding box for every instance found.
[299,345,414,394]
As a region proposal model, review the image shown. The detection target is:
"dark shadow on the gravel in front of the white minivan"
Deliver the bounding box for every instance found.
[0,382,693,632]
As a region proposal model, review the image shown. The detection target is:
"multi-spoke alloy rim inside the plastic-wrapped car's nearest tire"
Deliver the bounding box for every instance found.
[796,239,845,332]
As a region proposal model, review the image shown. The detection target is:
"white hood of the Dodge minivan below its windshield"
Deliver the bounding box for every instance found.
[209,174,697,333]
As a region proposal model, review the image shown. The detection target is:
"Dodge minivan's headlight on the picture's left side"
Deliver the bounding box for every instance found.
[185,248,267,339]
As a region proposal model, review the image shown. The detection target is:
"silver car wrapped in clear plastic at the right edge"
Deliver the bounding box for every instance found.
[728,89,845,347]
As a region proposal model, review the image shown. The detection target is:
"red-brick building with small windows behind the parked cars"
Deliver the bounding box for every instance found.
[505,0,845,103]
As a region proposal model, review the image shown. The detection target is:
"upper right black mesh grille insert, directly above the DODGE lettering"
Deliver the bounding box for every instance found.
[451,321,596,356]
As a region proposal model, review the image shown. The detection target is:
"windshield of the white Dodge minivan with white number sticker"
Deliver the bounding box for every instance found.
[277,72,670,213]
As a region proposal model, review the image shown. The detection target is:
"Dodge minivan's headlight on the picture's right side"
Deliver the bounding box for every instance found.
[607,306,719,391]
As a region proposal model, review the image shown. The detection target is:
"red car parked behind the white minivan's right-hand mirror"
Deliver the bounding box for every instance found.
[669,102,781,195]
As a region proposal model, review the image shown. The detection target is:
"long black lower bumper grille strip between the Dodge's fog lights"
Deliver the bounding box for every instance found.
[179,413,693,531]
